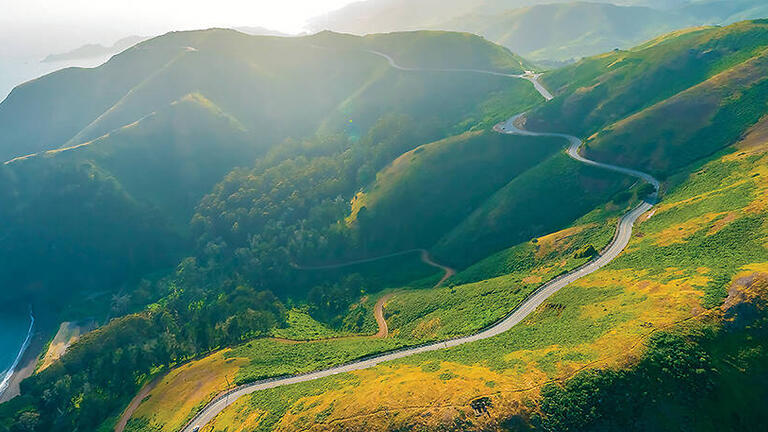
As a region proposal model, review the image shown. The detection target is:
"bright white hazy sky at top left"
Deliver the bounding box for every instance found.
[0,0,360,51]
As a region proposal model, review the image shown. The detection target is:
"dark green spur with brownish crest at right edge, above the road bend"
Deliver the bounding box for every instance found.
[586,46,768,173]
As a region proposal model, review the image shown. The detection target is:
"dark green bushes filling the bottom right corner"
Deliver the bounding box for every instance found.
[539,300,768,431]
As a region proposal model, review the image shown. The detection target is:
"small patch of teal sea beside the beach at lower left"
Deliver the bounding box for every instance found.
[0,308,32,393]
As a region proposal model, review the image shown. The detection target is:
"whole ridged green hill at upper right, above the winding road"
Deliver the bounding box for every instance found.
[527,21,768,173]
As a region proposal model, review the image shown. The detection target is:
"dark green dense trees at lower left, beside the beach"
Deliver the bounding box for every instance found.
[6,280,285,432]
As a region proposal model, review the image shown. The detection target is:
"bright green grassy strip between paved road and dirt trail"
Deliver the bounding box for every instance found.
[386,216,616,341]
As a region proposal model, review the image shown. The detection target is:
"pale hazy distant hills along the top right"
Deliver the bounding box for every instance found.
[312,0,768,64]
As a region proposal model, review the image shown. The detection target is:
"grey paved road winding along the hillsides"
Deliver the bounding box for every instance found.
[181,51,660,432]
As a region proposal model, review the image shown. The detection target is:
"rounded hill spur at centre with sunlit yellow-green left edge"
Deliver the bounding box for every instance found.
[348,131,560,255]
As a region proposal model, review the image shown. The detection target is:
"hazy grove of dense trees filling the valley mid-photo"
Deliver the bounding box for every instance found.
[192,115,429,293]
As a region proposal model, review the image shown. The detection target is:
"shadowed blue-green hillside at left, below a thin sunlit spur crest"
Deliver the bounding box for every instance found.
[0,95,259,301]
